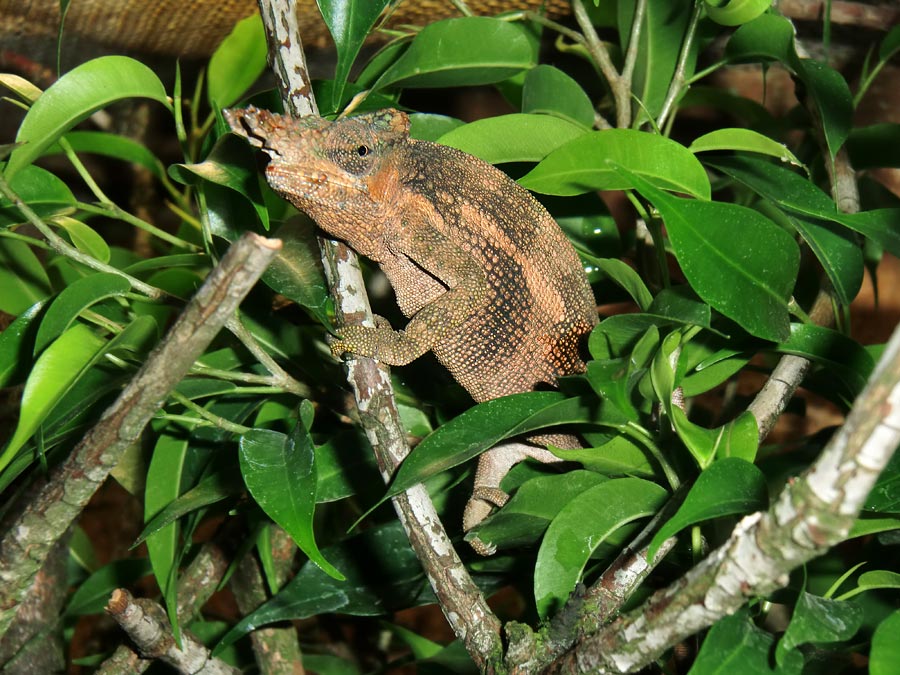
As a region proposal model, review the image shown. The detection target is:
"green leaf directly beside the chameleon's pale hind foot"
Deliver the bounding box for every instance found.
[466,470,608,549]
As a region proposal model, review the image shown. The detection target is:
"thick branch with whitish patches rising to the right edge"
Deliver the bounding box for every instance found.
[548,320,900,673]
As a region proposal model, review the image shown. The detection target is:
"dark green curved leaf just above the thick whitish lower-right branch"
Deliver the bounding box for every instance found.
[647,457,769,559]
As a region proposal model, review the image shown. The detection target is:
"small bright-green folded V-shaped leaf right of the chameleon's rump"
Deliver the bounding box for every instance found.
[672,406,759,468]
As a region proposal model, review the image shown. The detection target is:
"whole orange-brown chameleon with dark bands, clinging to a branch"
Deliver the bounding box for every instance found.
[225,107,597,553]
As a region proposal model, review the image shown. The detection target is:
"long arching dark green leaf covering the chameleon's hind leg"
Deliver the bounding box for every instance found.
[386,391,590,497]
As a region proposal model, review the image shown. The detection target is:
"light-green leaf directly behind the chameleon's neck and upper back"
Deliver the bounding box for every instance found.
[438,113,587,164]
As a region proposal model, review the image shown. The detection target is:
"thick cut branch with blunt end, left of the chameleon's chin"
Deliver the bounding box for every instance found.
[0,234,281,635]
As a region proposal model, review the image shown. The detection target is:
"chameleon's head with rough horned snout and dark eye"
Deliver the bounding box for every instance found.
[224,106,409,255]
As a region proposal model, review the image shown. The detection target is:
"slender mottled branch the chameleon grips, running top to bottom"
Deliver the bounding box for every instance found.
[259,0,502,672]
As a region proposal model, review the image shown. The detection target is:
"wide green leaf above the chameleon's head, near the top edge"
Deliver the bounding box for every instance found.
[373,16,536,90]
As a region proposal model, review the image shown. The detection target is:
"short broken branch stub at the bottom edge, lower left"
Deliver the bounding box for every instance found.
[106,588,241,675]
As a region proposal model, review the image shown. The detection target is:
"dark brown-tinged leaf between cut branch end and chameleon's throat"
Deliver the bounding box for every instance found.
[262,220,331,326]
